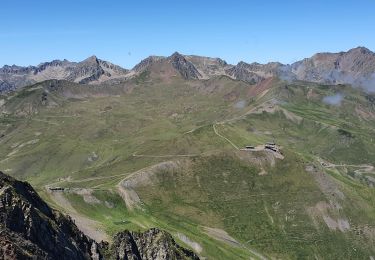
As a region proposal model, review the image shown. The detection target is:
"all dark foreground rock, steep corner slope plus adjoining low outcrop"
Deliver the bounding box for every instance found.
[0,172,199,259]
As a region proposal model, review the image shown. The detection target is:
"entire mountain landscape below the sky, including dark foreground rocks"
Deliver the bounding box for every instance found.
[0,45,375,260]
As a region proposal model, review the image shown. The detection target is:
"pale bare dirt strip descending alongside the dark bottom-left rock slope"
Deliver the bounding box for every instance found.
[48,191,109,242]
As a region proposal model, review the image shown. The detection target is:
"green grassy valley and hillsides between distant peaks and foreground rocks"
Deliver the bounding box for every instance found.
[0,49,375,259]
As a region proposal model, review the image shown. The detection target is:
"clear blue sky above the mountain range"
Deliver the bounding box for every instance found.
[0,0,375,68]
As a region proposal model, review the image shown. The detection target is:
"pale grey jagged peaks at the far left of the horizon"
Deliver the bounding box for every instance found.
[0,56,128,92]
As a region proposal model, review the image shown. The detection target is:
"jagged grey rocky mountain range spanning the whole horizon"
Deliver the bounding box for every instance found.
[0,47,375,92]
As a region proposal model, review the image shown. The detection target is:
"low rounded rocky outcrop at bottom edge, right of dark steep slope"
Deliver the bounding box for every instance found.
[111,228,199,260]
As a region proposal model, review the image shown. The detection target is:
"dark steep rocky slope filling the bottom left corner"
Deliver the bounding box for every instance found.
[0,172,101,259]
